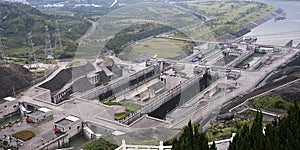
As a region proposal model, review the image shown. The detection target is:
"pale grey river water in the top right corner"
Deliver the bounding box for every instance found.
[246,0,300,46]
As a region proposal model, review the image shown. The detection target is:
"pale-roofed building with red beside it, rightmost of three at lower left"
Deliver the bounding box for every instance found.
[54,116,82,138]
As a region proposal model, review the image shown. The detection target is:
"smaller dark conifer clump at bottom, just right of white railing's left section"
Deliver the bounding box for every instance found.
[171,121,217,150]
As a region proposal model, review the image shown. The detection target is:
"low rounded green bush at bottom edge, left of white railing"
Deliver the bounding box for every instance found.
[84,138,118,150]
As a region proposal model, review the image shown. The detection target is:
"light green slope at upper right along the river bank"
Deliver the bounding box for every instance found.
[175,2,275,40]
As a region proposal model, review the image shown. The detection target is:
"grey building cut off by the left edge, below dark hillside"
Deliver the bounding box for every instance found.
[0,97,19,120]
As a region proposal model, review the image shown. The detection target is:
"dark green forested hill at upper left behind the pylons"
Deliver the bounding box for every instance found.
[0,2,91,57]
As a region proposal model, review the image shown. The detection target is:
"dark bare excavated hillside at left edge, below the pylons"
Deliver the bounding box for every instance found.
[0,64,33,98]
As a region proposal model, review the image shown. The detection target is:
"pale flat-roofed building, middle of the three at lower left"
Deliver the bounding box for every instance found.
[26,107,53,123]
